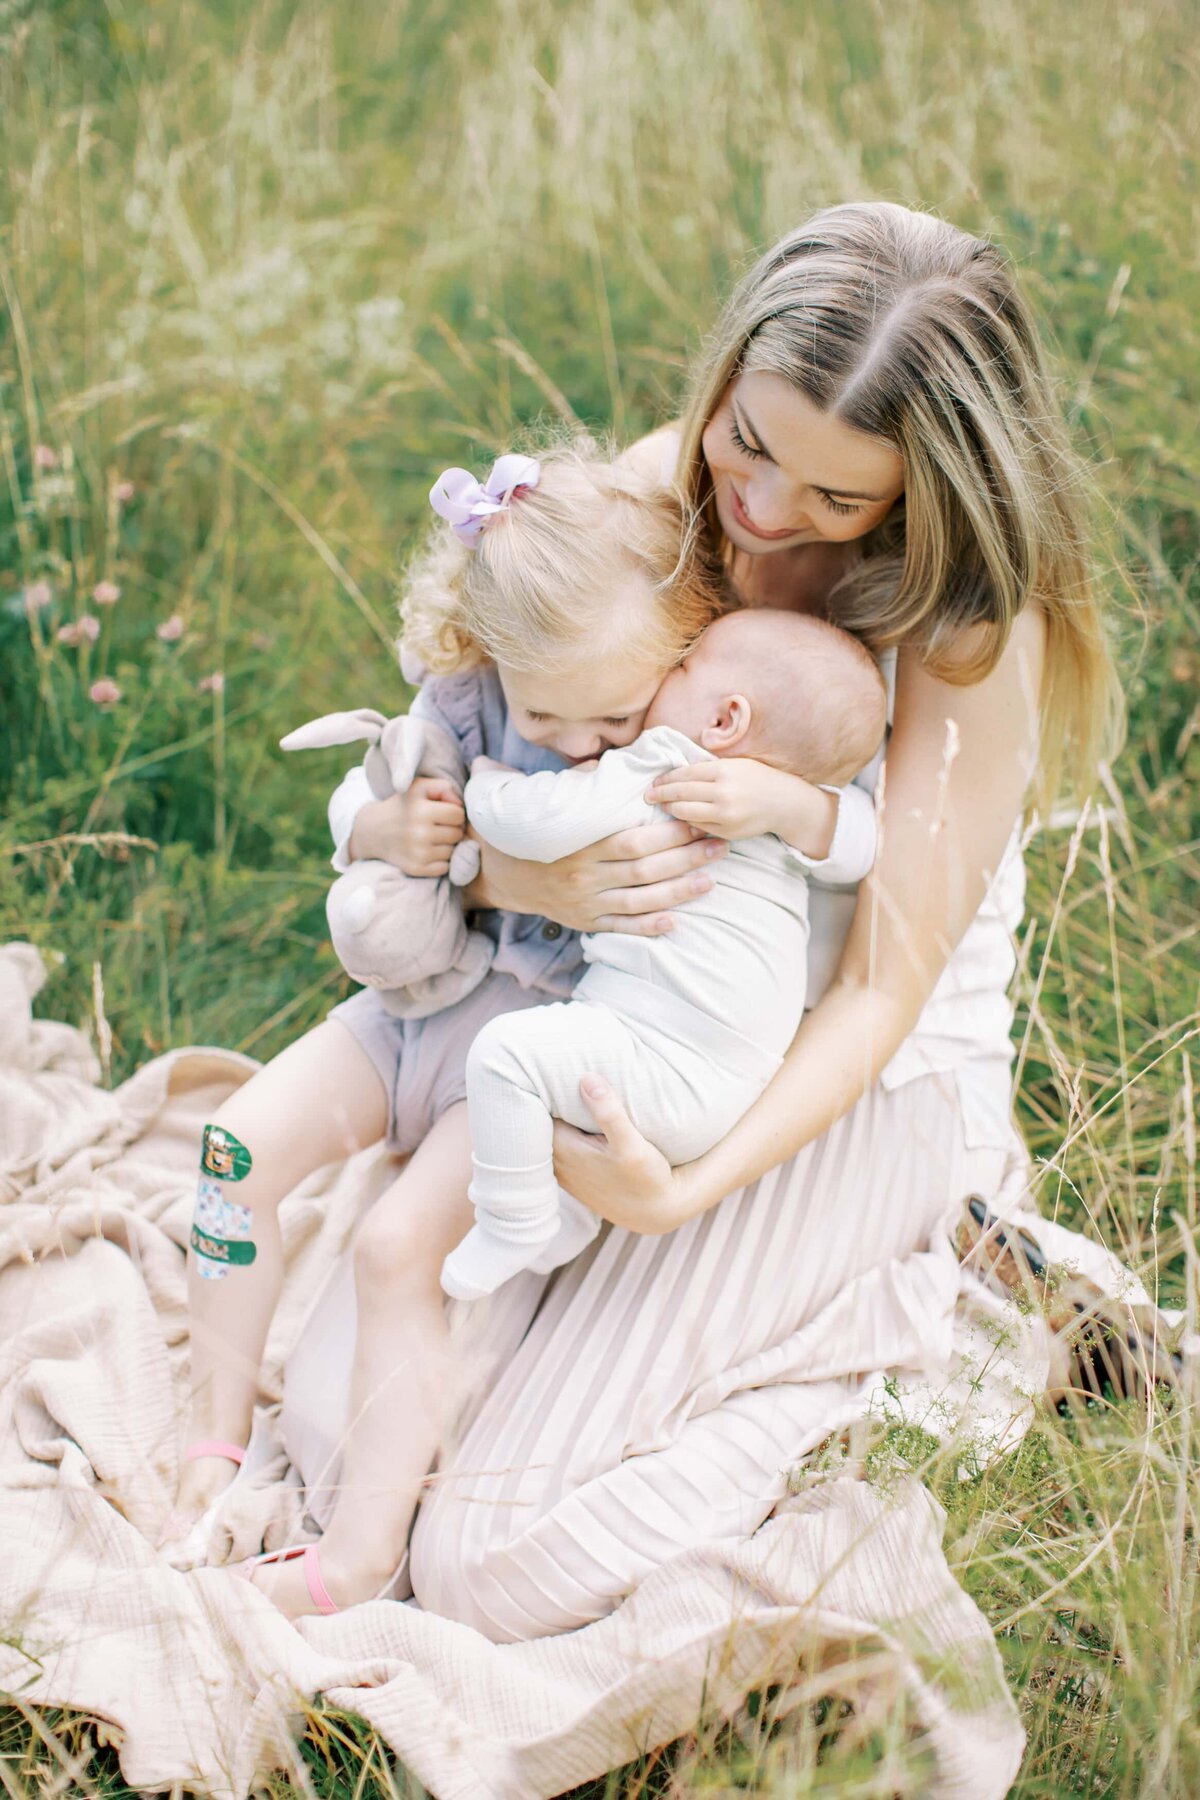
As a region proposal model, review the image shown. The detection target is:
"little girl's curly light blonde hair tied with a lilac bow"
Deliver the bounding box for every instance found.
[401,441,729,675]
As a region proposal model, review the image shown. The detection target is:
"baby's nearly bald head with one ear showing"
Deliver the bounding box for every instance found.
[646,607,887,787]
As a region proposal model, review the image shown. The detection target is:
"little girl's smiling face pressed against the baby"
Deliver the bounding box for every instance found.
[498,662,662,763]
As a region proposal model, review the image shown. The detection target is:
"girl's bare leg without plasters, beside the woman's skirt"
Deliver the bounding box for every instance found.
[241,1105,471,1618]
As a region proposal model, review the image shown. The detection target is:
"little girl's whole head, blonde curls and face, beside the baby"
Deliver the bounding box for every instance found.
[403,445,729,761]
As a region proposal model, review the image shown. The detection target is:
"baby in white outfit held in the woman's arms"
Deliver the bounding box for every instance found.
[443,608,887,1300]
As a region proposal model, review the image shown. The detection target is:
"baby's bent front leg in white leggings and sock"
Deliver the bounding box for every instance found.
[443,1001,646,1300]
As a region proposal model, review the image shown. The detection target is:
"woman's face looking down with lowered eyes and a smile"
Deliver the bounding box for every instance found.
[703,371,905,556]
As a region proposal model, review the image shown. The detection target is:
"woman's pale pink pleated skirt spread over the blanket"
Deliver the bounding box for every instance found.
[412,1076,1004,1636]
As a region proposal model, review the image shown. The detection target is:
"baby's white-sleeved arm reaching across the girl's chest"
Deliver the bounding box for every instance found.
[466,727,694,862]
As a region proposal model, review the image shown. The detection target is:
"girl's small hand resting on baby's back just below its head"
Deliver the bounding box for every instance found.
[646,756,838,862]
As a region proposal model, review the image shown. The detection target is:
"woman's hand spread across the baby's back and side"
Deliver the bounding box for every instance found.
[464,821,727,938]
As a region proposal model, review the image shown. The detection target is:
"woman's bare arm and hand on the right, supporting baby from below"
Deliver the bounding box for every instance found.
[556,610,1043,1231]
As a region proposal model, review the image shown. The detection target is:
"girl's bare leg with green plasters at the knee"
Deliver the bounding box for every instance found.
[175,1019,387,1530]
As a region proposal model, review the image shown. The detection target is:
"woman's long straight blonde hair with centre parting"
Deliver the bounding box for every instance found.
[678,202,1121,799]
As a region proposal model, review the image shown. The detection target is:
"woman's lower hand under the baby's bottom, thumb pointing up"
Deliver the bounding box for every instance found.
[554,1075,702,1237]
